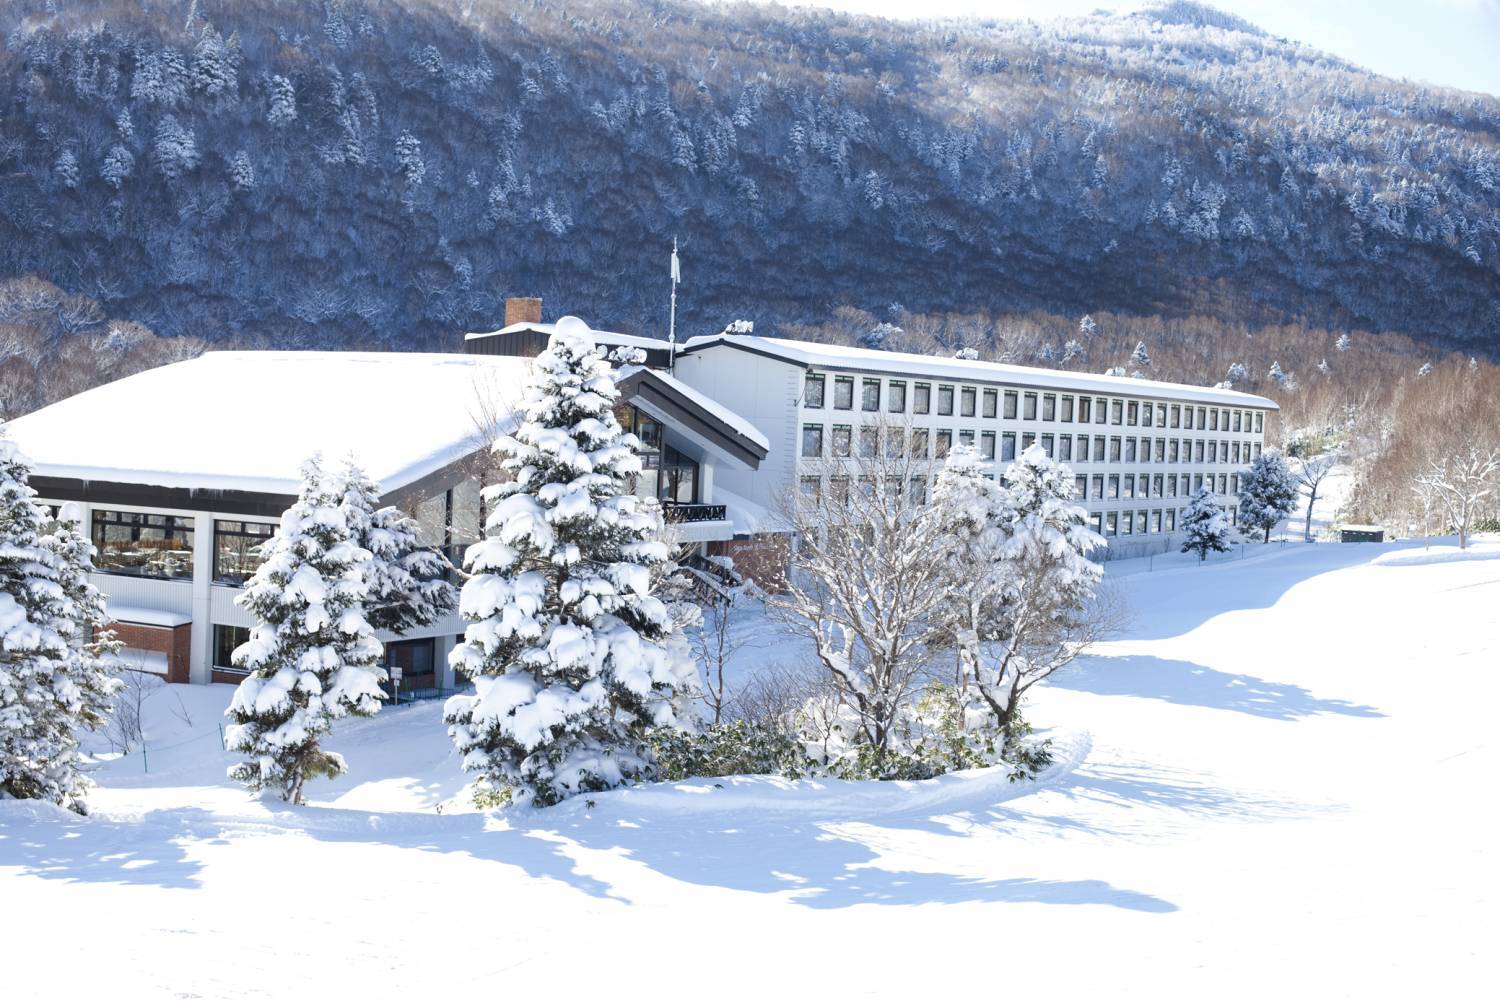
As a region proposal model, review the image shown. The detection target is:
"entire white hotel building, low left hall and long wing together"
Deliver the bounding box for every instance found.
[8,300,1277,690]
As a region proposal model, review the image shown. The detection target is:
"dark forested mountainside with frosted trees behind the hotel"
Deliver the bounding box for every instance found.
[0,0,1500,354]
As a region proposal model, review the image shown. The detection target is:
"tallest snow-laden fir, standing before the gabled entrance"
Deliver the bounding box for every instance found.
[447,316,698,805]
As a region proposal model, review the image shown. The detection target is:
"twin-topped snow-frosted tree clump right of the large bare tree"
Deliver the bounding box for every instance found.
[933,445,1113,739]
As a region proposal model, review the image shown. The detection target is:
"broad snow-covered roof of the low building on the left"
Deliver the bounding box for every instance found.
[6,351,531,495]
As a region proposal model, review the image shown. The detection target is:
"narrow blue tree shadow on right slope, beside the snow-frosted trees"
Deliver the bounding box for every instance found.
[1049,655,1385,720]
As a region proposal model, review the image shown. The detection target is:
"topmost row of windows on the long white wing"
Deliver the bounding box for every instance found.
[803,372,1266,433]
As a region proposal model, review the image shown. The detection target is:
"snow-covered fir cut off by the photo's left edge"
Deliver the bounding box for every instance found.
[0,436,119,813]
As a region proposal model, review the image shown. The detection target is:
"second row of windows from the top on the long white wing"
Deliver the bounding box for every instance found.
[803,424,1262,465]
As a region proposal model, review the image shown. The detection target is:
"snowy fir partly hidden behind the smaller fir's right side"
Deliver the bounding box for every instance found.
[339,460,458,636]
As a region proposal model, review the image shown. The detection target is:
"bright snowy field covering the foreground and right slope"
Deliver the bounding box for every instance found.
[0,540,1500,999]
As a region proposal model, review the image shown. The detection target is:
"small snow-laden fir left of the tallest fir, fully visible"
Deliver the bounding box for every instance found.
[225,459,386,804]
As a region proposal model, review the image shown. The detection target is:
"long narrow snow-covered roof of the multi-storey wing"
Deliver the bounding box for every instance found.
[681,333,1280,409]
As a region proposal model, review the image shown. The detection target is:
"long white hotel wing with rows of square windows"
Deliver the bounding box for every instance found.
[675,336,1277,556]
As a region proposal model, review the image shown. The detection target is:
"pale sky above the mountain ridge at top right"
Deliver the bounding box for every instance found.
[750,0,1500,96]
